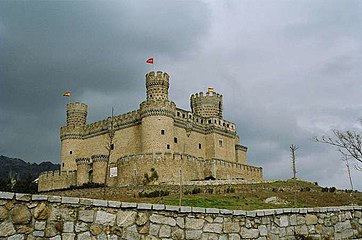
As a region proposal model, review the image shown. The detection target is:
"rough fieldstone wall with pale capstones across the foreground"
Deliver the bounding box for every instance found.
[0,192,362,240]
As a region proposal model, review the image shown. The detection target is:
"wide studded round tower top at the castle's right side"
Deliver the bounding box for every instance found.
[190,90,222,118]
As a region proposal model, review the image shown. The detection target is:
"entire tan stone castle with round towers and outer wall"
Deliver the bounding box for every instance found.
[39,71,263,191]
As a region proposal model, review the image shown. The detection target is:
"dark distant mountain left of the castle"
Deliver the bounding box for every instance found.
[0,155,60,180]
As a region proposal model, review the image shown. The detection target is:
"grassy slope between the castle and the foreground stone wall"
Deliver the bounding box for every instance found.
[49,180,362,210]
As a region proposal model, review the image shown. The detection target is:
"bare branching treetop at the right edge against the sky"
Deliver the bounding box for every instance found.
[314,121,362,163]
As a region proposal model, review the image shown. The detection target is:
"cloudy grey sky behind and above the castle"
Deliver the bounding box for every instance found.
[0,0,362,190]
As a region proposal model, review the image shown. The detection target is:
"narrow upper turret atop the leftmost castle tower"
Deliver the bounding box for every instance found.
[67,102,88,128]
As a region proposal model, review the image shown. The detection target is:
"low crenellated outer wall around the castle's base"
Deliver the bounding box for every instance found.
[38,152,263,192]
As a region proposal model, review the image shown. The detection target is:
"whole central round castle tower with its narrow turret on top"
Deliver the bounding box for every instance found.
[140,71,176,153]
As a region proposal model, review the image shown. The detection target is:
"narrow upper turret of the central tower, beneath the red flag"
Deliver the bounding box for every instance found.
[146,71,169,101]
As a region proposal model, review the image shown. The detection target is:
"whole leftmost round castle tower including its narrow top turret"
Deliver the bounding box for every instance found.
[60,102,88,171]
